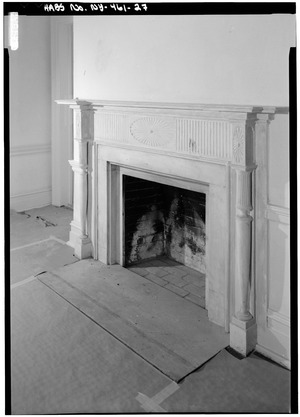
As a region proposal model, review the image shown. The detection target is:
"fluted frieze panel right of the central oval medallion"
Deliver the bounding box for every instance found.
[176,119,232,160]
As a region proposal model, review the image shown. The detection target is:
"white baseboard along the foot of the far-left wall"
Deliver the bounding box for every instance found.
[10,188,52,211]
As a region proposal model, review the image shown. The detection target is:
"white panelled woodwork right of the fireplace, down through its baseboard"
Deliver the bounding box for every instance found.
[255,114,292,367]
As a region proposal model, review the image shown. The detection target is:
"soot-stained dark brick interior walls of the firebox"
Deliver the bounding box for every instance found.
[123,176,206,272]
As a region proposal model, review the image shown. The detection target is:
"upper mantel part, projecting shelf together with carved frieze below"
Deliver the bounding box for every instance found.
[57,99,286,166]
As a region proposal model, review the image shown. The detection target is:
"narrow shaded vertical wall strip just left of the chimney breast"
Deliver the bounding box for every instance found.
[50,16,73,206]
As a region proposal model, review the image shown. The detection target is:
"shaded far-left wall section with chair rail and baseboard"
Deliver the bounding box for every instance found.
[9,16,51,210]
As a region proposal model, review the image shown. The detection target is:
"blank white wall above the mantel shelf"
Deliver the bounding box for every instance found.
[74,15,295,105]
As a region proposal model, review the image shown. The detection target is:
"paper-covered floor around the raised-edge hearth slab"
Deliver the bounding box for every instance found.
[11,207,290,415]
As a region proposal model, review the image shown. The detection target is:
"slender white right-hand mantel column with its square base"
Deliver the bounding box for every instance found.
[230,111,274,356]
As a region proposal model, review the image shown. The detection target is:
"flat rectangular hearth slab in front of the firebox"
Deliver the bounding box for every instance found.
[38,259,229,382]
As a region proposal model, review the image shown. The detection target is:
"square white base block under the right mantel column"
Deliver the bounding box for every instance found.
[230,317,257,357]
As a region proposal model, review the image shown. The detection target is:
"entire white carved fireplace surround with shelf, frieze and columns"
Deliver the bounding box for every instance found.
[57,99,276,355]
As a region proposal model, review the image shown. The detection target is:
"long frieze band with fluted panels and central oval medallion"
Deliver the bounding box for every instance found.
[95,112,232,161]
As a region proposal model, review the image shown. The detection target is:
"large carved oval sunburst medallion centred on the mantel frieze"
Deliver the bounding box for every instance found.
[130,117,175,146]
